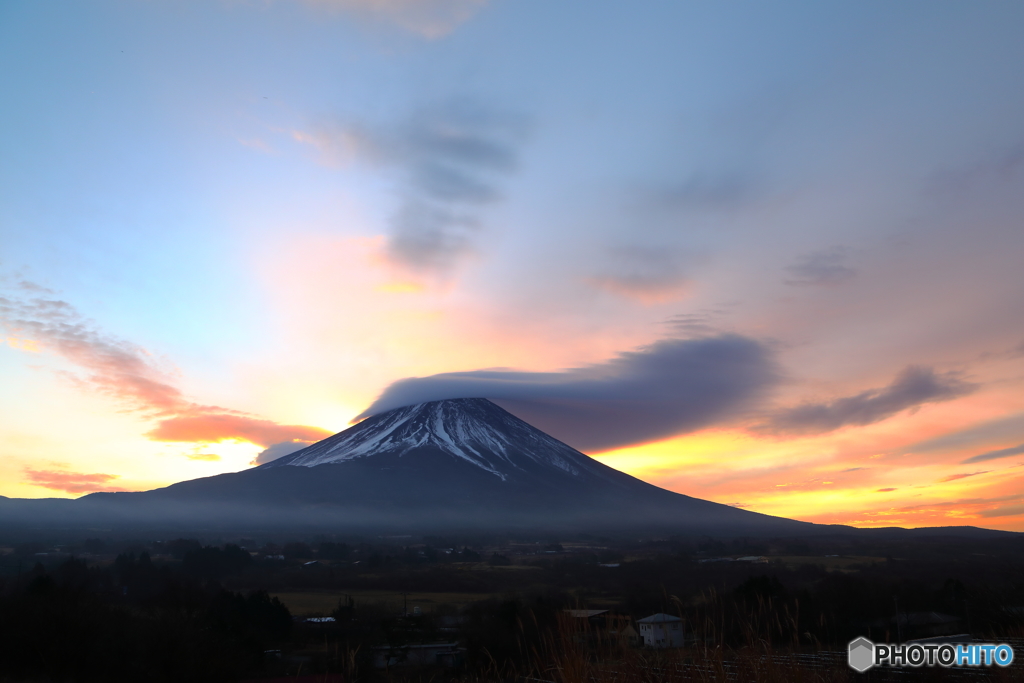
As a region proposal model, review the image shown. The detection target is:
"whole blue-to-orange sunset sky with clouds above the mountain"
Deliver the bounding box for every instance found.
[0,0,1024,530]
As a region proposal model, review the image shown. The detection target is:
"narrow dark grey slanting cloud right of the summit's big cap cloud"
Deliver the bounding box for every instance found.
[758,366,976,433]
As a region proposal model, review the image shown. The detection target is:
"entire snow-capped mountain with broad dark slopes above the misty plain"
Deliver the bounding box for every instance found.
[0,398,815,536]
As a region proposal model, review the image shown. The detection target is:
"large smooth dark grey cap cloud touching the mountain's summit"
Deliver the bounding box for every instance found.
[359,335,777,451]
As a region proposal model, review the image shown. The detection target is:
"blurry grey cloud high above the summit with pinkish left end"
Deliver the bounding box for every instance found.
[294,100,529,274]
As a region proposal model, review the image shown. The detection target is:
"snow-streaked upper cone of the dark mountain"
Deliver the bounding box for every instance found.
[263,398,609,489]
